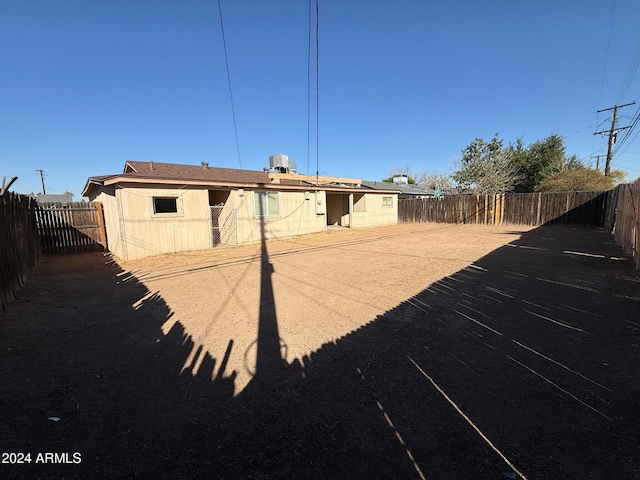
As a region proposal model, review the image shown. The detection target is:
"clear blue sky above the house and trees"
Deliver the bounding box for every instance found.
[0,0,640,199]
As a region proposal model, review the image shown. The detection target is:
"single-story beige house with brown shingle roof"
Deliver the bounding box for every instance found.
[82,161,398,260]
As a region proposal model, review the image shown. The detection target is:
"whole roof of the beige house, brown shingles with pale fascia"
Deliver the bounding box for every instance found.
[82,160,400,196]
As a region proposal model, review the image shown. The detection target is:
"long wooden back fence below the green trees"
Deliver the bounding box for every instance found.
[398,191,611,227]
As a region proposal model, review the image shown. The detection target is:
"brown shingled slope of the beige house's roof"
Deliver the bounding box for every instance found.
[124,160,270,184]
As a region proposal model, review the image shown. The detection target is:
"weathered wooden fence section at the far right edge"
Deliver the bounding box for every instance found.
[606,178,640,269]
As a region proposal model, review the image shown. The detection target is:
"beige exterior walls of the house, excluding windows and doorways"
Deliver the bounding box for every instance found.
[91,184,398,260]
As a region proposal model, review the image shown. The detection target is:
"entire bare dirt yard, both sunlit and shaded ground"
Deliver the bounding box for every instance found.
[0,224,640,479]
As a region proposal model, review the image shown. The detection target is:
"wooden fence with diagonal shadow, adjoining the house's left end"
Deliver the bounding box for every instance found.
[35,202,107,253]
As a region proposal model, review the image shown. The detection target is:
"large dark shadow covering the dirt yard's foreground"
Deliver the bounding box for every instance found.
[0,227,640,479]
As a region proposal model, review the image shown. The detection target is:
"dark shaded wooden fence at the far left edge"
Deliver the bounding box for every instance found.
[0,193,41,312]
